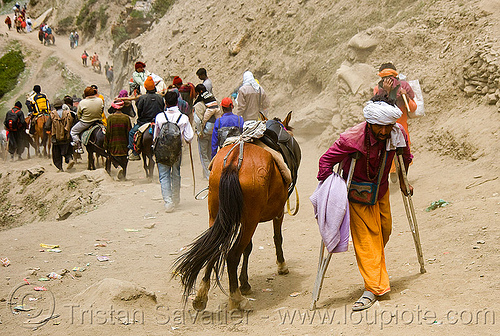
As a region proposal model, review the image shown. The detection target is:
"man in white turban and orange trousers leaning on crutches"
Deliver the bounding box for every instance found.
[317,96,413,311]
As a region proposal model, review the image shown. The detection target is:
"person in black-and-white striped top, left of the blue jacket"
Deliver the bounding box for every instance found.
[194,84,222,180]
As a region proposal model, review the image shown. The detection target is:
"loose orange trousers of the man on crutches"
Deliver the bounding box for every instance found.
[349,190,392,295]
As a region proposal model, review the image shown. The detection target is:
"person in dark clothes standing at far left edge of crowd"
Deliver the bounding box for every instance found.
[3,101,26,160]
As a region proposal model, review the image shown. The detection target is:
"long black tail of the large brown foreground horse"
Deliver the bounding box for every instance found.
[172,165,243,300]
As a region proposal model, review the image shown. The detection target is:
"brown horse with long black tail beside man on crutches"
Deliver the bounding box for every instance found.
[173,116,296,310]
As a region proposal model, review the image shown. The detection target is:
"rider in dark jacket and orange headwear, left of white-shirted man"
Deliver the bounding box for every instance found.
[128,76,165,161]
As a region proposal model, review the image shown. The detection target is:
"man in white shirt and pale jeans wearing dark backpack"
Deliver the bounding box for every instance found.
[153,91,194,212]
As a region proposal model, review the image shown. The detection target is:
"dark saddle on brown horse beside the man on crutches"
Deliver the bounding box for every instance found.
[260,120,302,196]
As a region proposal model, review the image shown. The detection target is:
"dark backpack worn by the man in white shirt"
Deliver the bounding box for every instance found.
[153,112,182,166]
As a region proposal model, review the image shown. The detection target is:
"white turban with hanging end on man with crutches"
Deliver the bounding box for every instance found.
[363,100,406,151]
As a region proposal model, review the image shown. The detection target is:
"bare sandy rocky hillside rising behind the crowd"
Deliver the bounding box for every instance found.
[5,0,500,168]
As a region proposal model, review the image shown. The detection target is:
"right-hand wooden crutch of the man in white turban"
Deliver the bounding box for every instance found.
[394,148,426,274]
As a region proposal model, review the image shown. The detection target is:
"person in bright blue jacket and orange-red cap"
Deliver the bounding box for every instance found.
[212,97,243,159]
